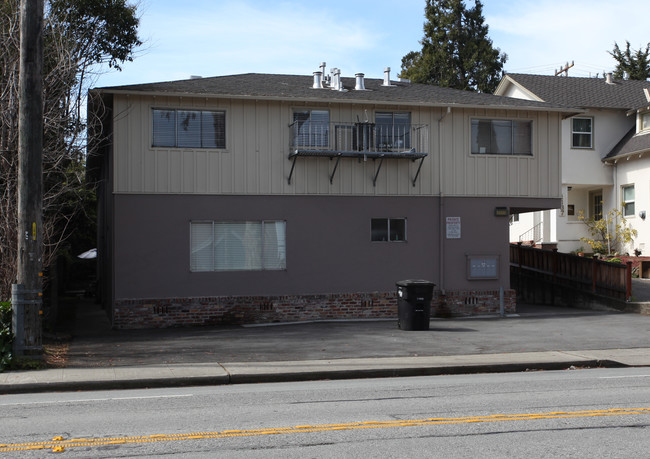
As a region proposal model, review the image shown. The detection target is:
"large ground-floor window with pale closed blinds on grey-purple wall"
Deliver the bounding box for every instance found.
[190,221,287,271]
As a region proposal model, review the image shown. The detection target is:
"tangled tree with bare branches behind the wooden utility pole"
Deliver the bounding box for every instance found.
[0,0,141,299]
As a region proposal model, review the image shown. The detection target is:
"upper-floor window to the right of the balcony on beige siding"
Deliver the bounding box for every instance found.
[472,119,533,155]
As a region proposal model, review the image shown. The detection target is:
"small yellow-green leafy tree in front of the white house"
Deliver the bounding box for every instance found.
[578,208,638,255]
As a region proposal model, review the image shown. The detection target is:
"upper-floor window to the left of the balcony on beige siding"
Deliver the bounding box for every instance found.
[151,109,226,148]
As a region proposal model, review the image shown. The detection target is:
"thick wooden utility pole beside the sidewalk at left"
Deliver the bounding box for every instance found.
[12,0,44,355]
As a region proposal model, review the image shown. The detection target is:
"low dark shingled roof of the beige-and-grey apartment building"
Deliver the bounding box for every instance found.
[92,73,567,112]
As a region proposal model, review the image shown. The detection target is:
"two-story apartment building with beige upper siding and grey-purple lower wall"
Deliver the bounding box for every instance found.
[88,64,567,327]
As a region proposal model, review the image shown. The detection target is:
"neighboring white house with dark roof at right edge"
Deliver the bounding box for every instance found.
[495,74,650,254]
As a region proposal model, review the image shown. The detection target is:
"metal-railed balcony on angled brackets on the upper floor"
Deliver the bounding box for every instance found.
[288,121,429,186]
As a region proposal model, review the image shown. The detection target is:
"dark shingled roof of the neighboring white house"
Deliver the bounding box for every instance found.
[501,73,650,110]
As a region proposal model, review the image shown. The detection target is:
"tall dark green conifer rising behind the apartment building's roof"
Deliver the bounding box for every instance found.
[399,0,507,93]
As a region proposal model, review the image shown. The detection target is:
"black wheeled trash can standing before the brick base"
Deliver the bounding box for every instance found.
[396,279,435,330]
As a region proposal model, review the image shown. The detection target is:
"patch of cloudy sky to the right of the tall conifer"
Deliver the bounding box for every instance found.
[485,0,650,76]
